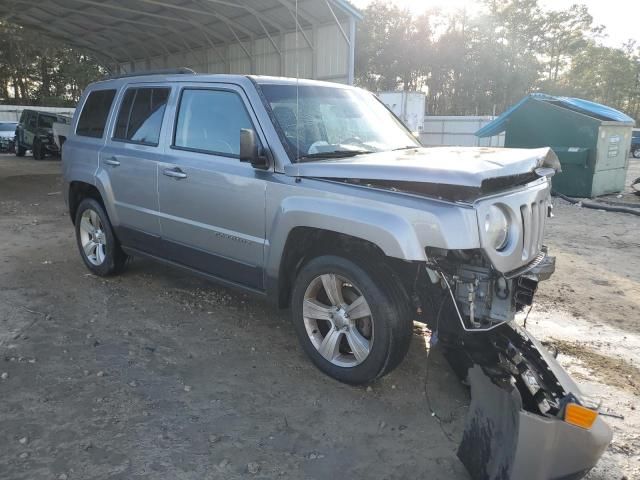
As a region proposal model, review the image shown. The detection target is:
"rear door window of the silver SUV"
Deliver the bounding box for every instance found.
[113,88,170,145]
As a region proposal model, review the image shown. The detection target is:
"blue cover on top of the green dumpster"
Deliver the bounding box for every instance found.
[476,93,635,138]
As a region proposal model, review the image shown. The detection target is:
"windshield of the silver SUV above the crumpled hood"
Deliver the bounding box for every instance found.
[261,84,420,162]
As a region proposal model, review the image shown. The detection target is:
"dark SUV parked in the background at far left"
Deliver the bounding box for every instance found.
[15,110,69,160]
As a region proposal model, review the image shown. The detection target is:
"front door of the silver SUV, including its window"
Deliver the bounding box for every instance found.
[158,84,271,290]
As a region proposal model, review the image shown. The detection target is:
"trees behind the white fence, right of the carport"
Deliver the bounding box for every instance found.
[356,0,640,119]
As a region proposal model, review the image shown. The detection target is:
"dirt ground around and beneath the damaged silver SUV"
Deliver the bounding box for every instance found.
[0,155,640,480]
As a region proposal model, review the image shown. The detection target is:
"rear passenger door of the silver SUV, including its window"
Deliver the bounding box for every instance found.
[98,84,171,246]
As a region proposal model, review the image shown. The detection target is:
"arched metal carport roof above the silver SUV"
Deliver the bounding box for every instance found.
[0,0,362,63]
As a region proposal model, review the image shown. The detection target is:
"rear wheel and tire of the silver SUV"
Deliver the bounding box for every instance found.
[75,198,128,277]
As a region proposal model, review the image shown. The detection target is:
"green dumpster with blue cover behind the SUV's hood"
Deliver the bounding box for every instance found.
[476,93,635,198]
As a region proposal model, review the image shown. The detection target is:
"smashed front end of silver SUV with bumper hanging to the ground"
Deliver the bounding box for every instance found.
[424,247,611,480]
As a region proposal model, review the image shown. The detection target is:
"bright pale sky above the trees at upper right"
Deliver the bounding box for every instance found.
[351,0,640,47]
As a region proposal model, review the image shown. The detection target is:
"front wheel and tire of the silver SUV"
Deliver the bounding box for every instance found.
[291,255,413,385]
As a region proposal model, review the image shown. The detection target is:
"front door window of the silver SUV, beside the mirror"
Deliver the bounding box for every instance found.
[174,89,253,157]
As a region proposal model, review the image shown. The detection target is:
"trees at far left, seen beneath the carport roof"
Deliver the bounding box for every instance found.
[0,22,106,107]
